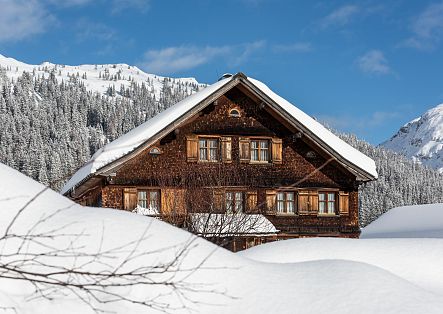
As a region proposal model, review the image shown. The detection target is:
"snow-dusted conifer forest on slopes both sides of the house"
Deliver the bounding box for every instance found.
[0,69,443,226]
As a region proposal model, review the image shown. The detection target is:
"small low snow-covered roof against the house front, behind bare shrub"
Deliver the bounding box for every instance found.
[189,213,278,236]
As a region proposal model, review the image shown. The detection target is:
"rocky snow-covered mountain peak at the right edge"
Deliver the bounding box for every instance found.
[381,104,443,173]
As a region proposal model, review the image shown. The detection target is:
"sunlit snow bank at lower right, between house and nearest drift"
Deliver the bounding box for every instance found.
[241,238,443,296]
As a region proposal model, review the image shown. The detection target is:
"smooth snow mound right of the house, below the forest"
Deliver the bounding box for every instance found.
[361,204,443,238]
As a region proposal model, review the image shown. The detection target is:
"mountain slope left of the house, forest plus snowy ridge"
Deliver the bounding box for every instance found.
[0,56,204,189]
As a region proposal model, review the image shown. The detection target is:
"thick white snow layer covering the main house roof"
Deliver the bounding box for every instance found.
[61,74,377,194]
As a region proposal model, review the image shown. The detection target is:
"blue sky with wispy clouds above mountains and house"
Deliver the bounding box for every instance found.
[0,0,443,144]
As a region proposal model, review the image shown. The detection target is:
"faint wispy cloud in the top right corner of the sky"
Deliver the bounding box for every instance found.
[402,2,443,50]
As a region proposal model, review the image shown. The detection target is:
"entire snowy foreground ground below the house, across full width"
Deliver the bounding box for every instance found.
[0,165,443,314]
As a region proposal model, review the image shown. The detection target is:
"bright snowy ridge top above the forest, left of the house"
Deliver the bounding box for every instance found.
[0,54,204,99]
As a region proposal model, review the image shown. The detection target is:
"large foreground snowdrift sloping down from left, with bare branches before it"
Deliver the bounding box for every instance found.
[0,164,443,314]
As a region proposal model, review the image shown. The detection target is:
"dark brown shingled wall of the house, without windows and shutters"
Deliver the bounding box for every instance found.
[96,88,359,236]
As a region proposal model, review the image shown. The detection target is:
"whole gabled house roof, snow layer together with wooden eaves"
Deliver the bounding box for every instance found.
[61,73,377,194]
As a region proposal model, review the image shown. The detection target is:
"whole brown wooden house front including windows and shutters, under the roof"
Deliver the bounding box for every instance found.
[67,72,378,251]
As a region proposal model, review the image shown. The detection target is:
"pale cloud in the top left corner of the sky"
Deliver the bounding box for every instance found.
[0,0,54,42]
